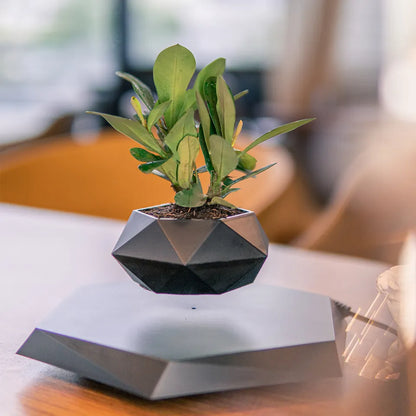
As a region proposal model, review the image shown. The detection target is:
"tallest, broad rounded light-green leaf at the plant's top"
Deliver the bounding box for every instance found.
[153,45,196,128]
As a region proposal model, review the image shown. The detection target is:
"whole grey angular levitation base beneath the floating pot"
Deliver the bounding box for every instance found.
[18,281,345,399]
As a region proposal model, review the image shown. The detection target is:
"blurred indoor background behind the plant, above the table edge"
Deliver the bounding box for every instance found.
[0,0,416,262]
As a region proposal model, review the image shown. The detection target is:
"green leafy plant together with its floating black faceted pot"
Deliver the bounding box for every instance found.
[90,45,312,294]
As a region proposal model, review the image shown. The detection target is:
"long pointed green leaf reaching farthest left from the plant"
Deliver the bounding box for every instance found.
[87,111,168,157]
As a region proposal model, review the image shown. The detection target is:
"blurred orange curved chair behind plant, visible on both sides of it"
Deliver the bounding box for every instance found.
[0,130,316,240]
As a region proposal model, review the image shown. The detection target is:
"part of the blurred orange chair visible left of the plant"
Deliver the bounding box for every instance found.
[0,131,185,219]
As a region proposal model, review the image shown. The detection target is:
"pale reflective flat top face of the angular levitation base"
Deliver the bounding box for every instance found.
[38,281,335,361]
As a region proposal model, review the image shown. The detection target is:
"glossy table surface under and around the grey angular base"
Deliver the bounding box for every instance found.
[0,204,401,416]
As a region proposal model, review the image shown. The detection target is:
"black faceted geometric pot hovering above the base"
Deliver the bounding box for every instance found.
[112,208,268,294]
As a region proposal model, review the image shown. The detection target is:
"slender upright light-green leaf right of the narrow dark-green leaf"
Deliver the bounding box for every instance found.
[216,76,235,143]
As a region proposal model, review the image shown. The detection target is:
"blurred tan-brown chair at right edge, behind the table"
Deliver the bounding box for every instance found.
[294,125,416,263]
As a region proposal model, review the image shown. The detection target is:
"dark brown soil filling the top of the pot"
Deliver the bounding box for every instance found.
[141,204,244,220]
